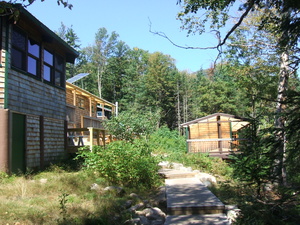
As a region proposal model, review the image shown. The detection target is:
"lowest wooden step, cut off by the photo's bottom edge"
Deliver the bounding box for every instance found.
[164,214,229,225]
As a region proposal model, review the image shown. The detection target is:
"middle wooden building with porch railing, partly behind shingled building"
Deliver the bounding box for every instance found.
[66,82,116,152]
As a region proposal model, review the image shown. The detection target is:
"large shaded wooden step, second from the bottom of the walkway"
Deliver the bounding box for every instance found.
[165,178,225,215]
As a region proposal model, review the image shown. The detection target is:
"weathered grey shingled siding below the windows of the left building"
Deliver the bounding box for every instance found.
[8,66,66,168]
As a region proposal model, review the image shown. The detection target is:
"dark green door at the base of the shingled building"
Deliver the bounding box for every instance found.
[11,113,26,173]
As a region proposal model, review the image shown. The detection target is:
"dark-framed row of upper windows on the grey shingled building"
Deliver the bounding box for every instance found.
[11,27,65,87]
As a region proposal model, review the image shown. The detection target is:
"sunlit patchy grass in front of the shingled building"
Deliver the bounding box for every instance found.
[0,163,155,225]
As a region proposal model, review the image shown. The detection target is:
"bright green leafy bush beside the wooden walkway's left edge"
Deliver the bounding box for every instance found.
[77,139,159,188]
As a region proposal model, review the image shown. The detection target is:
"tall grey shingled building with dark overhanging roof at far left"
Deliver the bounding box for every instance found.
[0,4,78,172]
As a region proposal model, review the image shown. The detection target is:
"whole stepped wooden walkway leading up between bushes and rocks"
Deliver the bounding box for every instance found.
[160,169,229,225]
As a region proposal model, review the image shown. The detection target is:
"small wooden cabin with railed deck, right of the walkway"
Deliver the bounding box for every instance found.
[181,113,249,158]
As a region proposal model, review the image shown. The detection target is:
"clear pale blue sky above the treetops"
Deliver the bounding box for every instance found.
[27,0,217,72]
